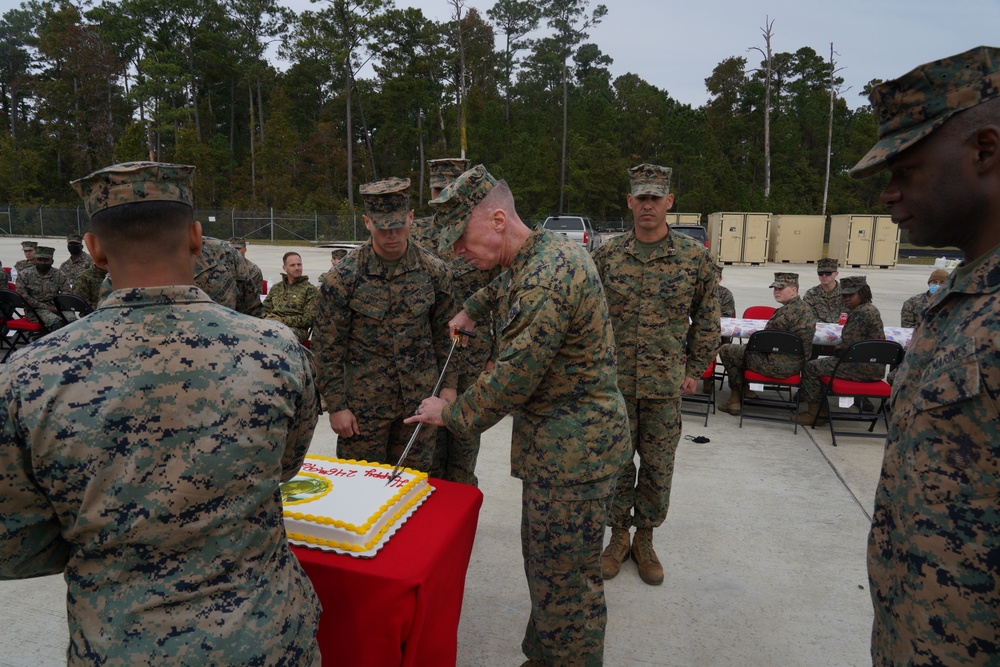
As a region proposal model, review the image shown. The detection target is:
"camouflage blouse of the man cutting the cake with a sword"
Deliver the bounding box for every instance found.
[441,230,631,487]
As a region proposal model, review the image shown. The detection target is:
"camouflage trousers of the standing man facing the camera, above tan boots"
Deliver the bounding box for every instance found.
[608,396,681,529]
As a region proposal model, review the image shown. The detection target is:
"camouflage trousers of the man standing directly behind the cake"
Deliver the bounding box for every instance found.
[337,411,440,477]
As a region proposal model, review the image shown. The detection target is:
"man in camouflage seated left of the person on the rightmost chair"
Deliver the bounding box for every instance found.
[719,273,816,415]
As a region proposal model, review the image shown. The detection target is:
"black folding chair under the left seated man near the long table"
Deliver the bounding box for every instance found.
[739,329,805,433]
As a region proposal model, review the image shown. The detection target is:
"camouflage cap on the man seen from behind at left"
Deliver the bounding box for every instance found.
[70,162,195,217]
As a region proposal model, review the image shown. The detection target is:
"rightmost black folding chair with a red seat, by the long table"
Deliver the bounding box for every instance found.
[813,340,904,447]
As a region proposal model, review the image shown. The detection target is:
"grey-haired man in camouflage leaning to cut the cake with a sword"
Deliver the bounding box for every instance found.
[418,165,629,666]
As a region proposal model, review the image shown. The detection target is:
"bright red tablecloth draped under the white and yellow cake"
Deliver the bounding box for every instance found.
[292,479,483,667]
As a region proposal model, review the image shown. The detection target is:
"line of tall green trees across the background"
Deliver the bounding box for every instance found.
[0,0,884,220]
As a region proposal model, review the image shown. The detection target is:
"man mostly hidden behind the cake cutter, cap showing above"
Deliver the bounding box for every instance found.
[424,158,500,486]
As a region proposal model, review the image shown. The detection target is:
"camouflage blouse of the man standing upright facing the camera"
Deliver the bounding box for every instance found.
[594,230,721,398]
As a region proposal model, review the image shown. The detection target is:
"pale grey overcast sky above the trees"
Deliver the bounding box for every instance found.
[0,0,1000,108]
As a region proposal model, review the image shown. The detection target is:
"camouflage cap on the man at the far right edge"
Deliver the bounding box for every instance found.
[850,46,1000,178]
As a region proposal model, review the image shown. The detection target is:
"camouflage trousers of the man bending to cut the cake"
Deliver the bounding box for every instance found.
[521,476,615,667]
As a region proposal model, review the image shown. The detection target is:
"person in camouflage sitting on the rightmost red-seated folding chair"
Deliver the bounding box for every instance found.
[797,276,885,425]
